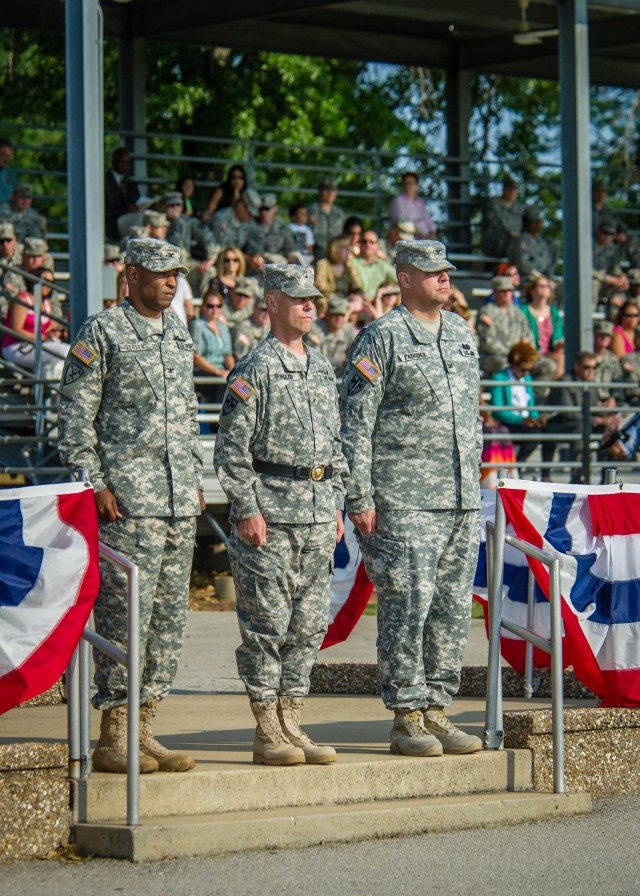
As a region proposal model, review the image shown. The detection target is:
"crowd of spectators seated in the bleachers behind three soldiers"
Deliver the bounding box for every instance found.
[6,139,640,476]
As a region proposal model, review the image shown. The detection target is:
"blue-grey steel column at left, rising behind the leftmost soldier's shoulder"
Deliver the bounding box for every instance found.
[65,0,104,328]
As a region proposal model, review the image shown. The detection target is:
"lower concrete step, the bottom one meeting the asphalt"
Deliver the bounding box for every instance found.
[75,792,591,862]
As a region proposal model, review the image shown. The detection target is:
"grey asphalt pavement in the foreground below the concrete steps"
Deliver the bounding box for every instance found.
[1,797,640,896]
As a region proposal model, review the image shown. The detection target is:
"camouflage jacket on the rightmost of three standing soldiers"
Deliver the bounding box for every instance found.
[340,305,482,514]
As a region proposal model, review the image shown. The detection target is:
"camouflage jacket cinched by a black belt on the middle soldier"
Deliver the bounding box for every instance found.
[213,333,346,525]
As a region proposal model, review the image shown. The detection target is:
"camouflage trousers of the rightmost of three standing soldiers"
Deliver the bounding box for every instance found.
[359,510,480,709]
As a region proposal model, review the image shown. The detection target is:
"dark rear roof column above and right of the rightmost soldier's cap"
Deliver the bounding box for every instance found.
[446,68,471,253]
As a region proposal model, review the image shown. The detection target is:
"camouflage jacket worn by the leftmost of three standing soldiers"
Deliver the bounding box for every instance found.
[58,301,202,517]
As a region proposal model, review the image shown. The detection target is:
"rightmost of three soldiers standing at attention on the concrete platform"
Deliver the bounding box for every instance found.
[340,240,482,756]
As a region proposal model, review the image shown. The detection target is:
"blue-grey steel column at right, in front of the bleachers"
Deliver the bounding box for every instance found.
[558,0,593,362]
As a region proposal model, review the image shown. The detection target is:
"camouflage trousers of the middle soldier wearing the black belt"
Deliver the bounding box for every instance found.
[227,522,336,701]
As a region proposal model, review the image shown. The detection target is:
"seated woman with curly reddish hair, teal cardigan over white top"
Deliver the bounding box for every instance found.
[491,342,554,461]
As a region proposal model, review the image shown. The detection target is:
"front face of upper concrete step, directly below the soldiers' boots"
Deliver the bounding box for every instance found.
[74,750,532,822]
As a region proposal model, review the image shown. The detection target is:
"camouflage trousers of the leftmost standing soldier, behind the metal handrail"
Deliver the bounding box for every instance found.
[93,516,196,709]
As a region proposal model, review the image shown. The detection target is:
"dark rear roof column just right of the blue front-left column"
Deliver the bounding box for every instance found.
[118,6,147,182]
